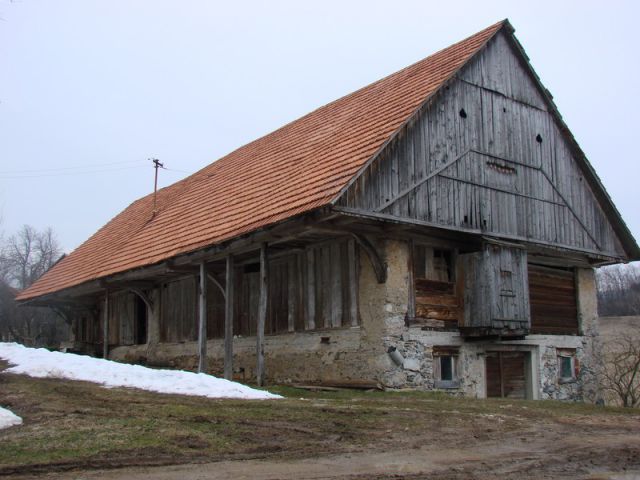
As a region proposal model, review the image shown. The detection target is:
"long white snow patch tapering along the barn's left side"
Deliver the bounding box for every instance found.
[0,343,282,400]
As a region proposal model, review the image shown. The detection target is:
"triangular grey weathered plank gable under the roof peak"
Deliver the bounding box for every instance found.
[338,30,624,256]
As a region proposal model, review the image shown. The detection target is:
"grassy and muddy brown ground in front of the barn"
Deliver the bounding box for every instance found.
[0,358,640,480]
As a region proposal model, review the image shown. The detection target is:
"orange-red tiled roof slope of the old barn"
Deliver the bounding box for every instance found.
[18,21,506,300]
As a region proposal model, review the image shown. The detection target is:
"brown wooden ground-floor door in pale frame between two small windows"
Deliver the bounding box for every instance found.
[486,351,532,399]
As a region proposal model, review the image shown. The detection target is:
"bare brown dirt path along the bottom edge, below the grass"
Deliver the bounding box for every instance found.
[33,432,640,480]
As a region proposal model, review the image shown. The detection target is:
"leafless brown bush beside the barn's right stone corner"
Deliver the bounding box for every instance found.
[602,328,640,407]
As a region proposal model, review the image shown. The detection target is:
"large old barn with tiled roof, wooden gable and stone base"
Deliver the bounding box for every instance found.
[19,21,640,399]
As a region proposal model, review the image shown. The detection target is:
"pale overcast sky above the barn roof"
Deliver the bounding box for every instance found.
[0,0,640,251]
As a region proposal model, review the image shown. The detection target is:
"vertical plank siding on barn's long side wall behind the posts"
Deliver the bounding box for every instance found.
[155,239,358,342]
